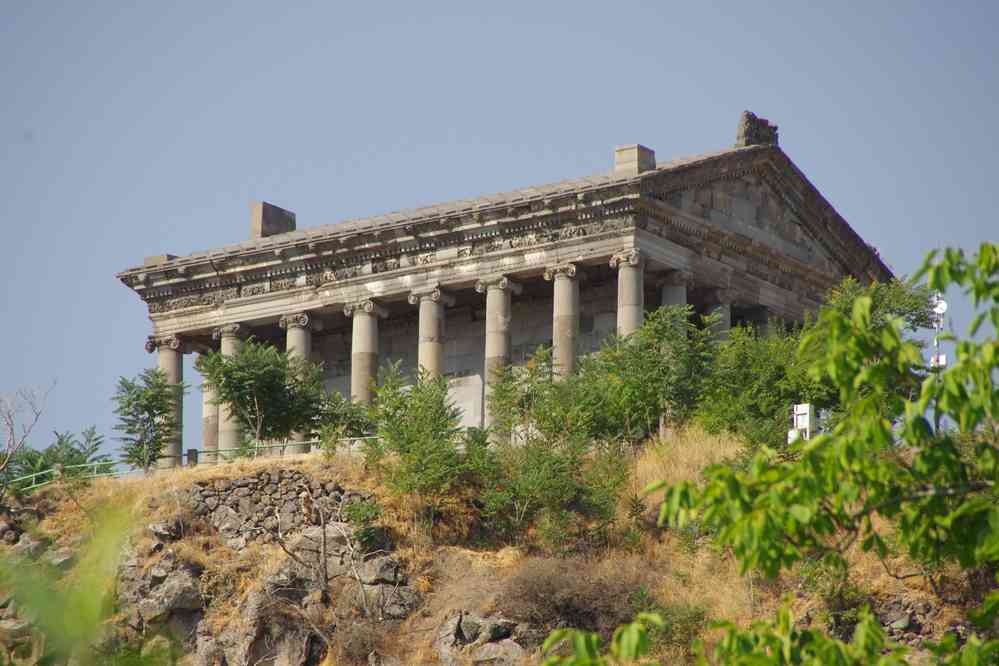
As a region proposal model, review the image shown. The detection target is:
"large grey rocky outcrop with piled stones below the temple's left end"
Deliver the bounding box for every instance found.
[118,470,421,666]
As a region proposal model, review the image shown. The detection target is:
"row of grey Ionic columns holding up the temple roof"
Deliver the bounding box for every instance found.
[147,249,729,466]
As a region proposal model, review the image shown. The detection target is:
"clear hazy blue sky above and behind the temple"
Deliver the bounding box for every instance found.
[0,0,999,447]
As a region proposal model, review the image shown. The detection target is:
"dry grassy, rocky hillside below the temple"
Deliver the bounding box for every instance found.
[0,428,975,666]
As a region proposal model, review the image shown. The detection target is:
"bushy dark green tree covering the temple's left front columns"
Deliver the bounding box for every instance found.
[197,340,324,442]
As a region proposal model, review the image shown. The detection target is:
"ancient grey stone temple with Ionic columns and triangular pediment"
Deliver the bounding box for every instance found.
[118,112,891,464]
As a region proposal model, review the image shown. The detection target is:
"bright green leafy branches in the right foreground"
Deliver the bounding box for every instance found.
[648,243,999,664]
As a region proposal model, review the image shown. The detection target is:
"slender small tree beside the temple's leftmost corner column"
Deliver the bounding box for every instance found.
[112,368,185,472]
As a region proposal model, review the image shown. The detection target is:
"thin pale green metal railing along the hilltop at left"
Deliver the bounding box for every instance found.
[7,435,378,492]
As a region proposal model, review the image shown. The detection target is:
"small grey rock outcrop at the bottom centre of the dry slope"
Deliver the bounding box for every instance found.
[434,610,528,666]
